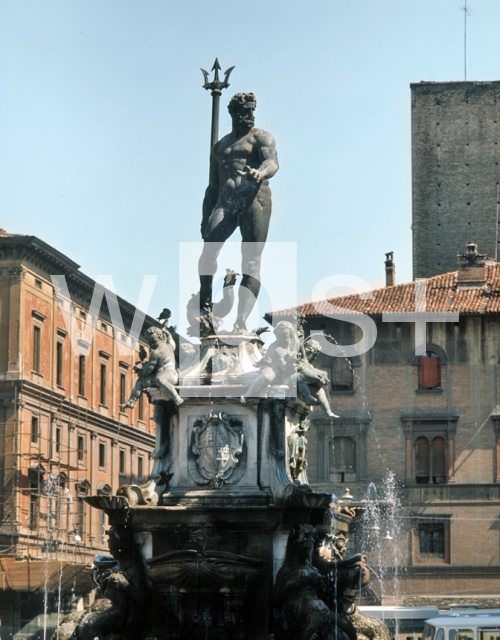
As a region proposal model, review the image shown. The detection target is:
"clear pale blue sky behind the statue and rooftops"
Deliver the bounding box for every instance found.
[0,0,500,328]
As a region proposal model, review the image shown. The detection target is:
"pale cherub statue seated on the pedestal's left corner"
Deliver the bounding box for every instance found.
[120,327,184,409]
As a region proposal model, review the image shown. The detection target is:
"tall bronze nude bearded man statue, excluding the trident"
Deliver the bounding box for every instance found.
[199,93,278,331]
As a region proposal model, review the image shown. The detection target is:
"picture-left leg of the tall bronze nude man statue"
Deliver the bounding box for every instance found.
[198,201,238,309]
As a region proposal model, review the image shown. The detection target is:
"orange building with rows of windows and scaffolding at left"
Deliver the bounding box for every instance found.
[0,233,156,632]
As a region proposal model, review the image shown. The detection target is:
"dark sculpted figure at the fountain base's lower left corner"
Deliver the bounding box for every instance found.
[52,527,152,640]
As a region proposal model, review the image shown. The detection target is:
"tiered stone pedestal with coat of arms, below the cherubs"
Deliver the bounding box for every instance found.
[99,387,314,640]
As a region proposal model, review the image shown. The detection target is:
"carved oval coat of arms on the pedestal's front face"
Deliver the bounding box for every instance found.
[188,412,247,489]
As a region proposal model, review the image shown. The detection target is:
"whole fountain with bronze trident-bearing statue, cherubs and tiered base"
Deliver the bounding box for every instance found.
[54,68,394,640]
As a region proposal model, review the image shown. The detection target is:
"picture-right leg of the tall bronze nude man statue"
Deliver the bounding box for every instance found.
[234,185,271,330]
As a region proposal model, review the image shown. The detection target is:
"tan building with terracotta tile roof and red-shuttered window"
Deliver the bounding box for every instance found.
[275,247,500,606]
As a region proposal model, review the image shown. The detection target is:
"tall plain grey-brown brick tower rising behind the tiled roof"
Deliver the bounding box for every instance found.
[411,81,500,278]
